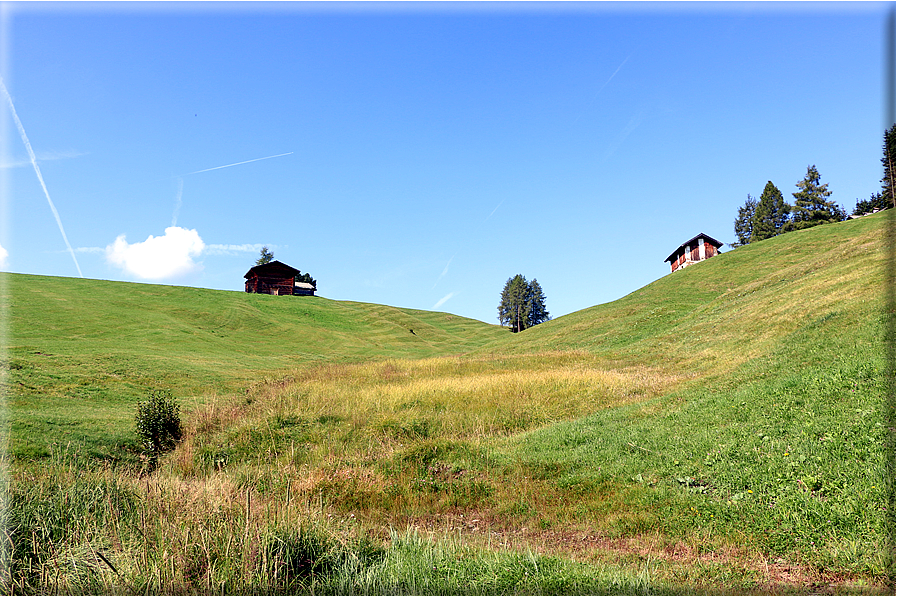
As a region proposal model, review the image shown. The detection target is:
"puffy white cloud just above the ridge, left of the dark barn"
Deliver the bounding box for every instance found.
[106,226,205,280]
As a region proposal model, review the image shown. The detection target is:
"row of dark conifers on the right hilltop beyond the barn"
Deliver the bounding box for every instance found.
[731,125,897,248]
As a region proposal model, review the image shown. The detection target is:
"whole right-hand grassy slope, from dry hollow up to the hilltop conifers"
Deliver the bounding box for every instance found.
[472,211,894,583]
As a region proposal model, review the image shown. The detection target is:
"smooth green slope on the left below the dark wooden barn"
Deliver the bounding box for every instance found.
[0,274,502,457]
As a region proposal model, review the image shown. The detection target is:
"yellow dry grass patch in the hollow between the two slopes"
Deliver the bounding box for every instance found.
[267,352,680,436]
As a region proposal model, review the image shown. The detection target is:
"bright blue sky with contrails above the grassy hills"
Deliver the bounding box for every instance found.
[0,2,894,323]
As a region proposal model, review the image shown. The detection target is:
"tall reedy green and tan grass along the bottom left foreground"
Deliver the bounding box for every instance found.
[0,451,708,595]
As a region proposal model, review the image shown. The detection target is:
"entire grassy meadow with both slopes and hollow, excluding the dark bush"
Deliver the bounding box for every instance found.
[0,210,895,595]
